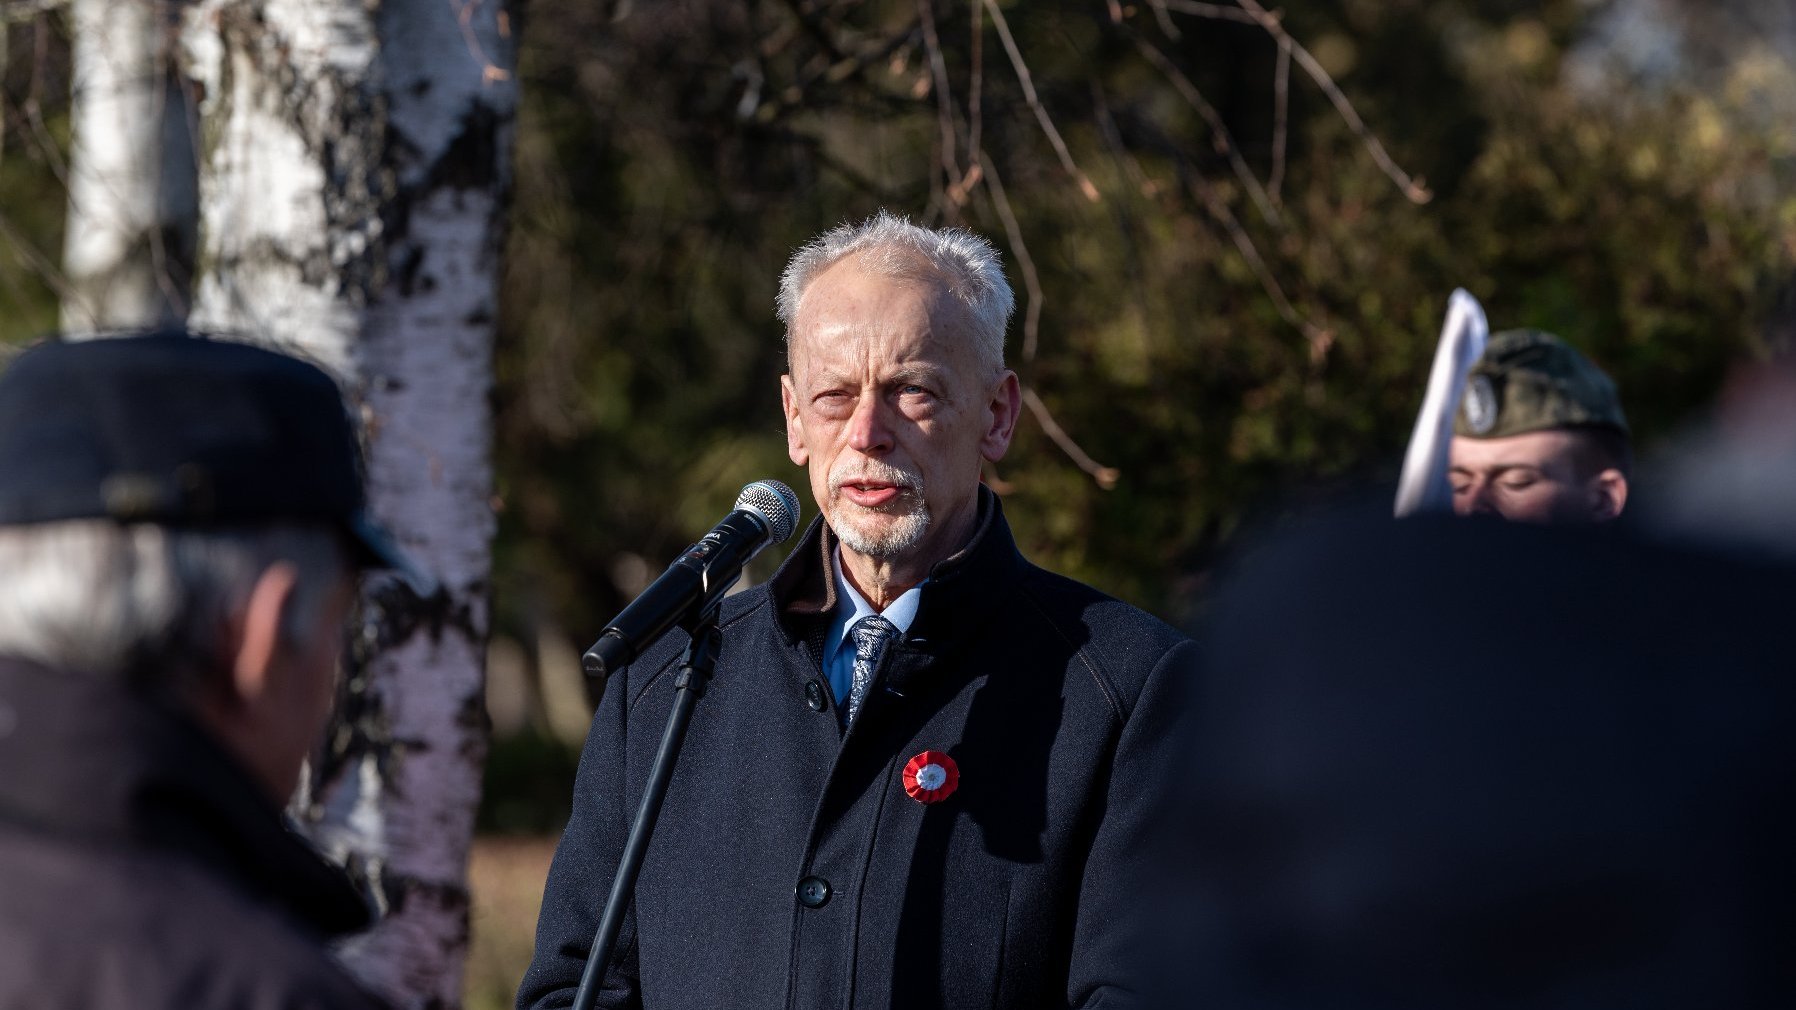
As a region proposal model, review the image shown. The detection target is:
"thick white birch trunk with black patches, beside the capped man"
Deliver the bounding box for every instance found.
[183,0,514,1008]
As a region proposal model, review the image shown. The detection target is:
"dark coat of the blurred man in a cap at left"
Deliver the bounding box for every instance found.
[0,660,389,1010]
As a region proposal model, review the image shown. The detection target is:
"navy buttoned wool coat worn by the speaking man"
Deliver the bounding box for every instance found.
[517,491,1189,1010]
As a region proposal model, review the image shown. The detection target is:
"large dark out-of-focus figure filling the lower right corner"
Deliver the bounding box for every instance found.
[1158,503,1796,1010]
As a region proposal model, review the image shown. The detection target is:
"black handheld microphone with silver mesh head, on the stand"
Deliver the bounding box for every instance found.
[580,480,797,679]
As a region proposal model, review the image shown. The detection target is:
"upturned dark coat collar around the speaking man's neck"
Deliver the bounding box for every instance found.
[769,483,1026,643]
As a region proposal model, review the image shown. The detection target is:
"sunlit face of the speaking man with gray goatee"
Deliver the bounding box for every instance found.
[779,259,1018,568]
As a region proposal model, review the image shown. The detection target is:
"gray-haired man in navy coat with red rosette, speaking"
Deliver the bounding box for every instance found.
[517,212,1189,1010]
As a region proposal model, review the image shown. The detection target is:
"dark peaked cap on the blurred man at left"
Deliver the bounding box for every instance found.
[0,331,429,586]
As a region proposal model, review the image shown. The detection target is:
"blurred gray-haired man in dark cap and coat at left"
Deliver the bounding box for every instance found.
[0,332,420,1010]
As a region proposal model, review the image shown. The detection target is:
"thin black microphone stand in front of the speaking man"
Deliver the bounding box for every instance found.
[573,597,724,1010]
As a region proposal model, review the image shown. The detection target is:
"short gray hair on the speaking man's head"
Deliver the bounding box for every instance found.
[778,210,1017,368]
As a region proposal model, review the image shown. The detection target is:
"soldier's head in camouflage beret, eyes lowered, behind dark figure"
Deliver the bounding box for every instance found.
[1448,329,1631,525]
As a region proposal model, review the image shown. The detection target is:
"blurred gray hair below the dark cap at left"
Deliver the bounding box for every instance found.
[0,519,350,694]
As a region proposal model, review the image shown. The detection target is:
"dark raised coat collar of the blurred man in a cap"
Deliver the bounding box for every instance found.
[0,658,370,936]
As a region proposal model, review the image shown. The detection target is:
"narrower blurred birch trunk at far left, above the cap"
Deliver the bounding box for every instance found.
[61,0,196,334]
